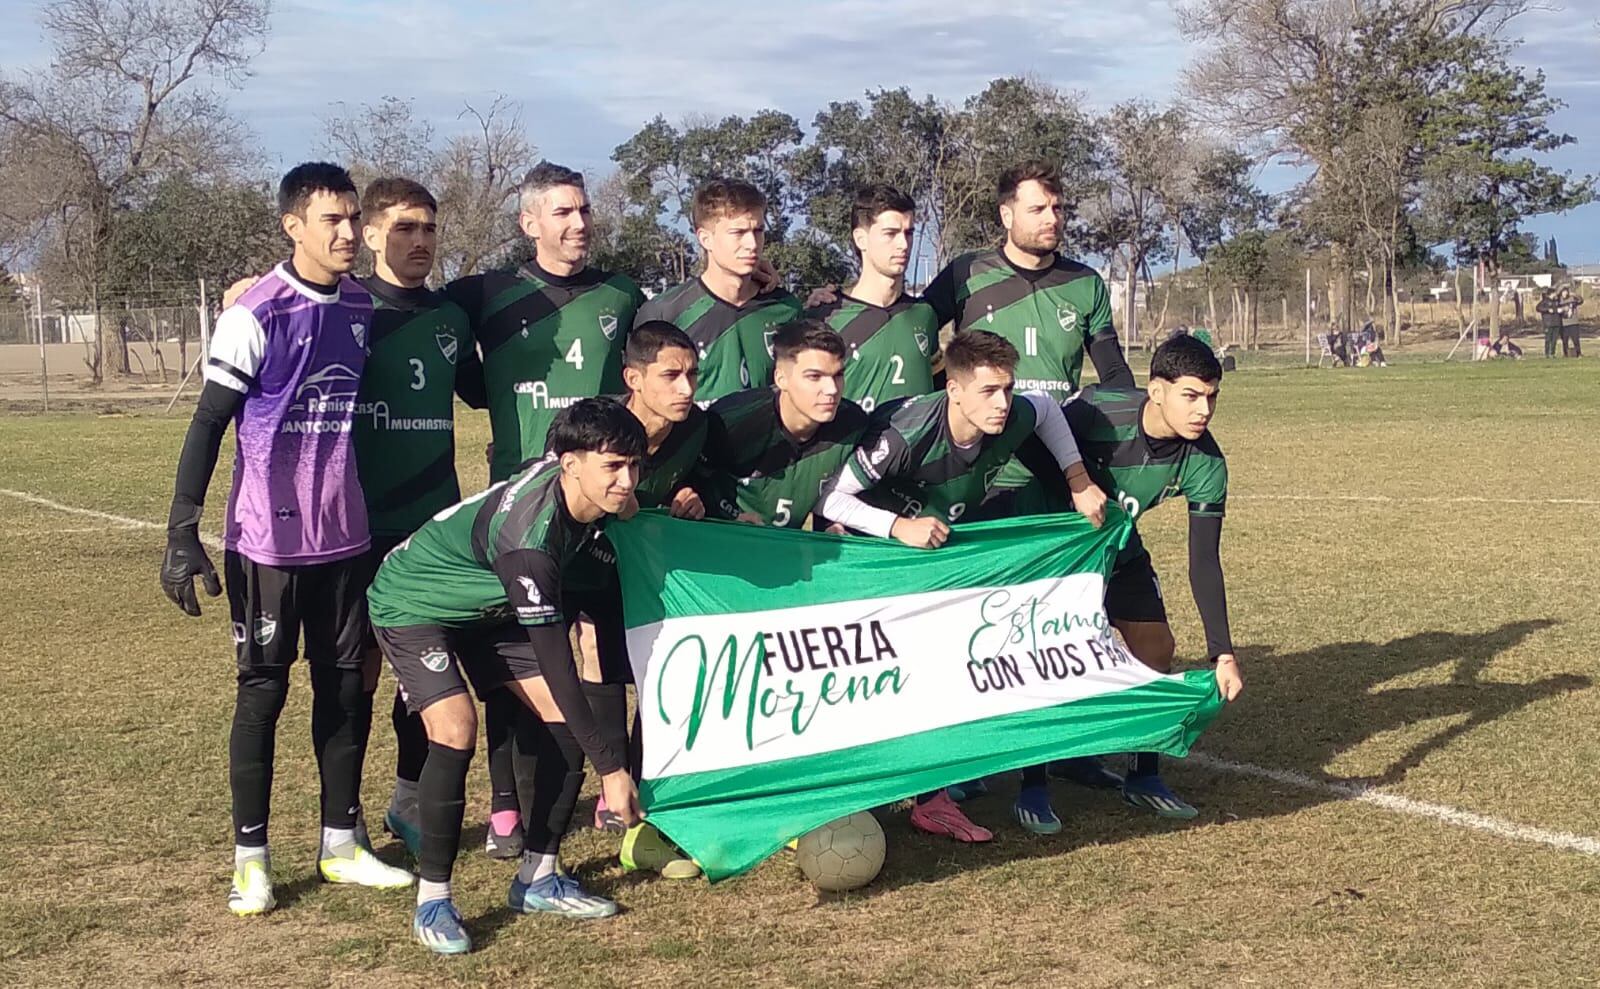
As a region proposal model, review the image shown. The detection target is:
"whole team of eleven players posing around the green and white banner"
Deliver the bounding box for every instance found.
[163,163,1242,952]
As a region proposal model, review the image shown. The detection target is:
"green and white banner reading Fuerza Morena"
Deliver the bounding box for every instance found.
[606,509,1221,880]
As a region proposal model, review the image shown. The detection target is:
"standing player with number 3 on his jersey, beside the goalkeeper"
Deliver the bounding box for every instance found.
[355,178,485,856]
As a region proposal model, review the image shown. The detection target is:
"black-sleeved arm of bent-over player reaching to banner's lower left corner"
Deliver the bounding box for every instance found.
[494,549,627,778]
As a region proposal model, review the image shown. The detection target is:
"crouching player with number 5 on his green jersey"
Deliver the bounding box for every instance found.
[701,318,867,531]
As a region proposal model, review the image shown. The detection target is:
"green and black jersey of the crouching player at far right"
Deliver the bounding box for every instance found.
[1061,384,1227,519]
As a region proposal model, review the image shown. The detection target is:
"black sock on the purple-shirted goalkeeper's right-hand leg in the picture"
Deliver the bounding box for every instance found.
[310,664,373,827]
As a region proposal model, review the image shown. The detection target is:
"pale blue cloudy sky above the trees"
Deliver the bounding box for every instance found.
[0,0,1600,264]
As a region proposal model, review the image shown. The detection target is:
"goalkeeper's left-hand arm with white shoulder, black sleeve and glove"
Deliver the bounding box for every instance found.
[162,307,267,615]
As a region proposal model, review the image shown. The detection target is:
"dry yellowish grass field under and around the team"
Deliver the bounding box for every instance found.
[0,360,1600,986]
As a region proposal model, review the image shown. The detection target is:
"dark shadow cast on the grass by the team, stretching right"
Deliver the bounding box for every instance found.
[844,619,1594,903]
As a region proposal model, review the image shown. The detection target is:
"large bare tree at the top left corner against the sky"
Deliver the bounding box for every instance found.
[0,0,269,381]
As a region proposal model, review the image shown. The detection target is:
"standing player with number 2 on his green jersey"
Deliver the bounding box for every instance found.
[806,186,939,413]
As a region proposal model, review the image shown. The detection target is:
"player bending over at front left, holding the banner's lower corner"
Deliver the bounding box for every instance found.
[368,398,646,954]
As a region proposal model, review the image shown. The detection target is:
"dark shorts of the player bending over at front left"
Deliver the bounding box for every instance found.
[373,623,539,714]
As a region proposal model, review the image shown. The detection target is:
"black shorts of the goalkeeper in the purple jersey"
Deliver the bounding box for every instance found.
[222,551,373,677]
